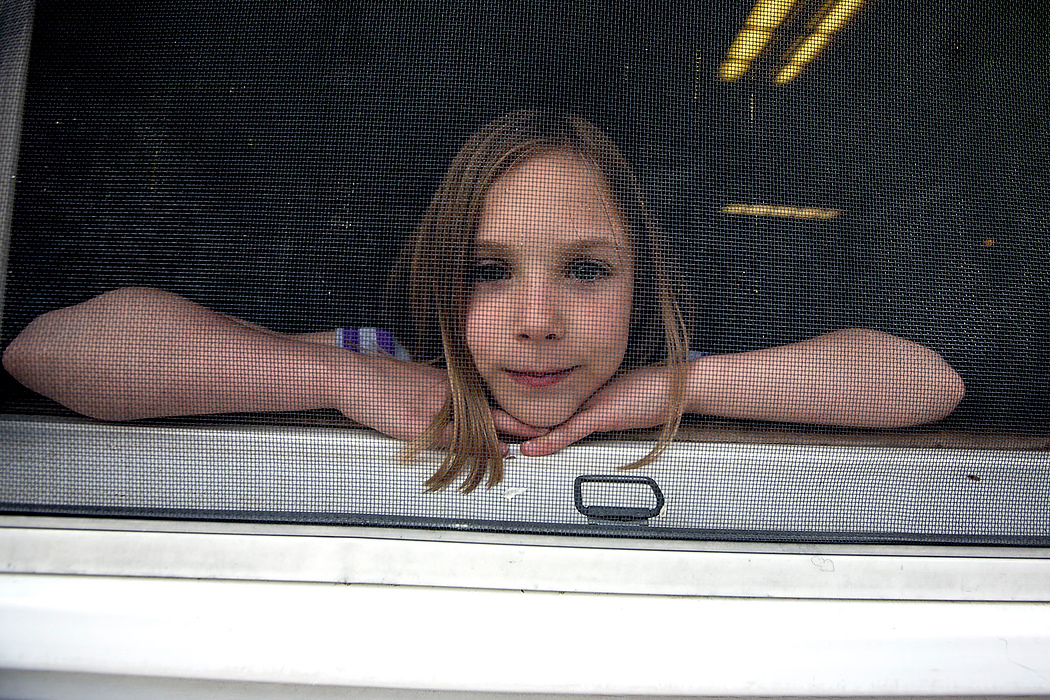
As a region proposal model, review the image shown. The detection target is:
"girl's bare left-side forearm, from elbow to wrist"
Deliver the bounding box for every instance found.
[3,288,375,420]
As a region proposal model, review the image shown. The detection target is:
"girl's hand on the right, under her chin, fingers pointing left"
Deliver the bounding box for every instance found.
[521,366,671,457]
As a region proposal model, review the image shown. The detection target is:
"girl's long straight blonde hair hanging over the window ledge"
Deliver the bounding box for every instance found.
[389,109,689,492]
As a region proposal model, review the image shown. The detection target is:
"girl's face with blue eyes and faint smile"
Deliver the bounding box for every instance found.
[466,153,634,427]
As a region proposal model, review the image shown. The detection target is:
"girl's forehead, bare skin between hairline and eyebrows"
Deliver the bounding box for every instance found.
[477,152,628,248]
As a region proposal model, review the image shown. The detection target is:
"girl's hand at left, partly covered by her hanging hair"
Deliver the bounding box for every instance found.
[332,355,546,449]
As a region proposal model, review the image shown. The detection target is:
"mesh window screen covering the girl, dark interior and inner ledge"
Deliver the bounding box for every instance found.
[0,0,1050,546]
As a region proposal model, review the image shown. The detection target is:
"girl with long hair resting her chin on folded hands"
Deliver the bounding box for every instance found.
[3,110,965,491]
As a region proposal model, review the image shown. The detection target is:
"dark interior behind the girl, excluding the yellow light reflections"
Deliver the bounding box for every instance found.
[0,0,1050,430]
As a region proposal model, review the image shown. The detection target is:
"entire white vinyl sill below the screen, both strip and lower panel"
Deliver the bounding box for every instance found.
[0,516,1050,700]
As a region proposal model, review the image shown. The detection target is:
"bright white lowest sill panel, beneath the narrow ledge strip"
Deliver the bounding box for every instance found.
[0,574,1050,700]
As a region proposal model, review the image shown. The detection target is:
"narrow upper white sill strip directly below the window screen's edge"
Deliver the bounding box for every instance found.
[0,515,1050,601]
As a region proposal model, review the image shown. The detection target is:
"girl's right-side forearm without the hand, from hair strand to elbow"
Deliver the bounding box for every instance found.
[686,328,966,428]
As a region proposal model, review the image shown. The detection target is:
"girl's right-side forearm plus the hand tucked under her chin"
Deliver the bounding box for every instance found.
[521,328,966,457]
